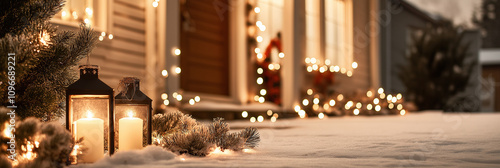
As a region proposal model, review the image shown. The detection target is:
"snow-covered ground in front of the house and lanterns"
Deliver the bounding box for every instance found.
[77,112,500,168]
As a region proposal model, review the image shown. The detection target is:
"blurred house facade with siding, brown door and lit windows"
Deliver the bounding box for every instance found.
[52,0,456,115]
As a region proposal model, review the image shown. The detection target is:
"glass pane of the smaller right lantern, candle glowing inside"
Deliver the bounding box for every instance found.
[115,104,150,151]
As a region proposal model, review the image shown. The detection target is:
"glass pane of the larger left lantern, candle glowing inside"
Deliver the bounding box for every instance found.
[67,95,110,163]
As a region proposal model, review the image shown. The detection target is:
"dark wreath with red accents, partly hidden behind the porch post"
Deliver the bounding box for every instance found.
[256,34,282,105]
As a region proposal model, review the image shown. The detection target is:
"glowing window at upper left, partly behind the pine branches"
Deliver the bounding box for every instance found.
[51,0,111,31]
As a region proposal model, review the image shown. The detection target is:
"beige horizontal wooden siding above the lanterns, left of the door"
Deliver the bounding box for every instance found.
[82,0,146,88]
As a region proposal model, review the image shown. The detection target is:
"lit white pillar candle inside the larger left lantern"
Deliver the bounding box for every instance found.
[75,111,104,163]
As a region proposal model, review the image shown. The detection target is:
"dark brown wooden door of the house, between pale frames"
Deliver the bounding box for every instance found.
[180,0,229,95]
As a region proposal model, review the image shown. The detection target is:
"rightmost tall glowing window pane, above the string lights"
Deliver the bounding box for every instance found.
[324,0,353,71]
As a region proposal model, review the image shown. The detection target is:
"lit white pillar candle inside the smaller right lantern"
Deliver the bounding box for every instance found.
[118,111,143,151]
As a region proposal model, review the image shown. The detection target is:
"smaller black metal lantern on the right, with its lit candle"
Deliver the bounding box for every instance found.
[114,77,152,151]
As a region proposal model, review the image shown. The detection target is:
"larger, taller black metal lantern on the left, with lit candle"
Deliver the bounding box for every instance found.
[66,65,114,163]
